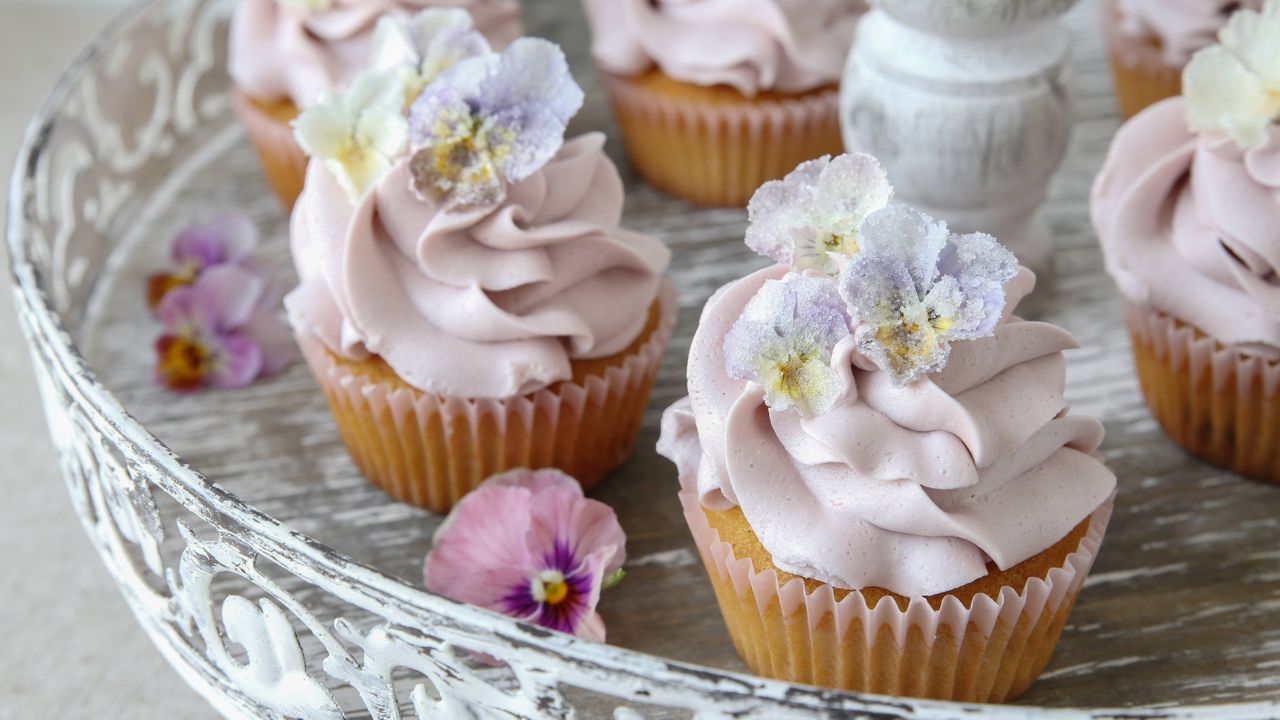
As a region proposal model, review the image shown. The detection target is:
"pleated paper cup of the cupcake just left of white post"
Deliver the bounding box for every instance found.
[600,72,844,208]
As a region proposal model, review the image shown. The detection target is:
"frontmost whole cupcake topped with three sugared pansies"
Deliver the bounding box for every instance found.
[659,155,1115,702]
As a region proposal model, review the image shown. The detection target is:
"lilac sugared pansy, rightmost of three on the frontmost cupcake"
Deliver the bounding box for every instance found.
[840,206,1018,386]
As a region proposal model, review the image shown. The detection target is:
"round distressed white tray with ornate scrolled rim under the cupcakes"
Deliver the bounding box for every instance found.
[8,0,1280,720]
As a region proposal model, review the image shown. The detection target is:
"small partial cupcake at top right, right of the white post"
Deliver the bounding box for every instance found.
[1103,0,1262,118]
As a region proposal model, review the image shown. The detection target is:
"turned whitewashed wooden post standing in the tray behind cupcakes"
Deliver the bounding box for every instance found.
[841,0,1075,311]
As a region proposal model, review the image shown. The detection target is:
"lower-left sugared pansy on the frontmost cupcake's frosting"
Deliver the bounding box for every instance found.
[724,275,849,416]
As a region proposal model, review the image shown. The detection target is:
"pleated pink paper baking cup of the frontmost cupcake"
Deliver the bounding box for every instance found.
[680,488,1111,702]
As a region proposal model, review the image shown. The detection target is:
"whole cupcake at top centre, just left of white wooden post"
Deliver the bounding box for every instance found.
[585,0,865,208]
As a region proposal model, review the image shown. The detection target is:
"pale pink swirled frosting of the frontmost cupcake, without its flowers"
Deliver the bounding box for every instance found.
[659,265,1115,596]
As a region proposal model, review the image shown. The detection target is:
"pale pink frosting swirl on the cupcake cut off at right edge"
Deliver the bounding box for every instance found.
[1091,97,1280,357]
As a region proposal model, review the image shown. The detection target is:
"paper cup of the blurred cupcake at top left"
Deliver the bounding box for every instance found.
[232,90,307,211]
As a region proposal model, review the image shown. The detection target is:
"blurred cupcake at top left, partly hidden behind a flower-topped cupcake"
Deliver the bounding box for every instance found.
[227,0,521,209]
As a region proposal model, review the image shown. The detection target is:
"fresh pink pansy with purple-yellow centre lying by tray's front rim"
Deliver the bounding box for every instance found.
[425,469,626,642]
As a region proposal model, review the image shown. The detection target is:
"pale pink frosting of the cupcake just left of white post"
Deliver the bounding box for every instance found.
[585,0,867,96]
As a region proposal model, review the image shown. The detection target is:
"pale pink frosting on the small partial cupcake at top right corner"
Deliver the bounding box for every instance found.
[1116,0,1262,67]
